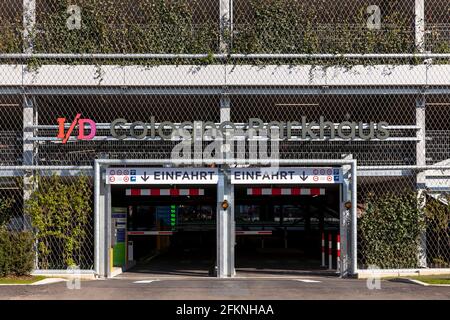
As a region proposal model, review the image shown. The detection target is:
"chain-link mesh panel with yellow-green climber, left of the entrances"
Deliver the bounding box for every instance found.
[0,167,94,270]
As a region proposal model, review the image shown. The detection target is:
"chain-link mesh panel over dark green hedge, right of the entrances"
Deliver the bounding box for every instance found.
[358,175,450,269]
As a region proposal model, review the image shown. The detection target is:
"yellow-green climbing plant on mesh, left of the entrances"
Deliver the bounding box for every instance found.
[25,175,93,268]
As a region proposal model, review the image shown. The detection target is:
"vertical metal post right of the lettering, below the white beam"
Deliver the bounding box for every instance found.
[416,95,427,268]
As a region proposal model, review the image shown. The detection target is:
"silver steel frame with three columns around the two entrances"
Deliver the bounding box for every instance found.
[94,159,357,278]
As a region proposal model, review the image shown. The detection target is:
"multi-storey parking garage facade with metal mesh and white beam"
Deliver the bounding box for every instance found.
[0,0,450,277]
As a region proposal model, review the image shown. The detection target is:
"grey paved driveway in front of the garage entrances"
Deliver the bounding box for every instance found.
[0,273,450,300]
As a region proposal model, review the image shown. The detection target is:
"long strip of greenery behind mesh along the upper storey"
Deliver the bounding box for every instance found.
[0,0,450,64]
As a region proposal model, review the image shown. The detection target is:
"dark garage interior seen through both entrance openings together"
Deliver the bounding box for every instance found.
[111,181,340,277]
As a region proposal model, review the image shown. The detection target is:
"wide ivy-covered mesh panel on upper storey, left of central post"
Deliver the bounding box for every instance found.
[35,0,219,53]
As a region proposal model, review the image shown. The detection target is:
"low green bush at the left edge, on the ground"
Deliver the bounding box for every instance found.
[0,228,35,277]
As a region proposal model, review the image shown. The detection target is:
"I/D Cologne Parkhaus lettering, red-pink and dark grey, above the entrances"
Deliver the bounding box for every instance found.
[57,114,390,144]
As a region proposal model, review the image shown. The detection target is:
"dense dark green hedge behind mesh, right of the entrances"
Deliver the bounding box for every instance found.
[358,192,425,268]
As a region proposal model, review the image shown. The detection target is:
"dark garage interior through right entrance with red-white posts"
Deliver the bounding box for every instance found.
[235,185,340,276]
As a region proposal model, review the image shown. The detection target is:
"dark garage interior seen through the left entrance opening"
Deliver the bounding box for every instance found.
[111,186,216,276]
